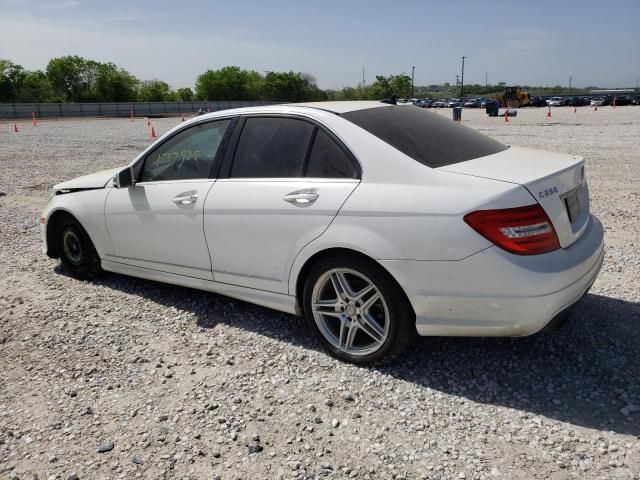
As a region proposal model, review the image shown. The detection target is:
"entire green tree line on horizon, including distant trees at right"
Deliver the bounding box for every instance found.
[0,55,596,103]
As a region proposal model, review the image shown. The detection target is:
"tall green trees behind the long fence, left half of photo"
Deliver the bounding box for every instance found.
[0,55,327,103]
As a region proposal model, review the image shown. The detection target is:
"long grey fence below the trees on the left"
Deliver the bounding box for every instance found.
[0,101,276,120]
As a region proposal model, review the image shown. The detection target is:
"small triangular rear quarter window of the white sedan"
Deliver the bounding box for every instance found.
[305,129,358,178]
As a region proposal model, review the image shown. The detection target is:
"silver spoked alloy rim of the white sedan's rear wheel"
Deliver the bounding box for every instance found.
[311,268,390,357]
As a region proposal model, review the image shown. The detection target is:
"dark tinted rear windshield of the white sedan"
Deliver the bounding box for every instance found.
[342,105,509,168]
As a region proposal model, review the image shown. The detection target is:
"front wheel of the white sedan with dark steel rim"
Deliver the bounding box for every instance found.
[56,215,102,280]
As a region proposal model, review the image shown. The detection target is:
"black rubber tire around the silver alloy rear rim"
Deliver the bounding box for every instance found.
[303,254,417,365]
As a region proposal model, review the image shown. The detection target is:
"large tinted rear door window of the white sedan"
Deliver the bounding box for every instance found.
[231,117,314,178]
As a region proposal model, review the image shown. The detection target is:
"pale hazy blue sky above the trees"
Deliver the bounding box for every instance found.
[0,0,640,88]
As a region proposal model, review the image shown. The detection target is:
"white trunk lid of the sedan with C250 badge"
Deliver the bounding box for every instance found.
[438,147,590,248]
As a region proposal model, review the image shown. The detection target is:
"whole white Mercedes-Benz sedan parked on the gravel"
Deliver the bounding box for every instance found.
[40,102,604,364]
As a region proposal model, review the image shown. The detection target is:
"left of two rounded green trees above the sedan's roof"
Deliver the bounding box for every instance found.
[196,66,262,100]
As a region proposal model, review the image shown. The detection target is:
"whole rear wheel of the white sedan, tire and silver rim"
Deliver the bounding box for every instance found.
[304,256,416,365]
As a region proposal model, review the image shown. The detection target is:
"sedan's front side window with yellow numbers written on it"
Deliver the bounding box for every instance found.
[140,119,231,182]
